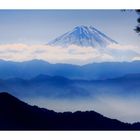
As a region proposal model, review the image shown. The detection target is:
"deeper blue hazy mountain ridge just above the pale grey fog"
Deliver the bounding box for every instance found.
[0,74,140,100]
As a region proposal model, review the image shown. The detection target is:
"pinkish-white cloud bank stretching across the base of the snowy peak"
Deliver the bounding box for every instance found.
[0,44,140,65]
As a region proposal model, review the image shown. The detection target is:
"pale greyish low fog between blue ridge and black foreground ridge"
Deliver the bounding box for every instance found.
[24,96,140,123]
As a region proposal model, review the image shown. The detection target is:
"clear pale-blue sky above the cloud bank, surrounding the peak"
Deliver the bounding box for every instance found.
[0,10,140,45]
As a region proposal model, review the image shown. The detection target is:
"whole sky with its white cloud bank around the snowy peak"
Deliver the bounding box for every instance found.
[0,10,140,65]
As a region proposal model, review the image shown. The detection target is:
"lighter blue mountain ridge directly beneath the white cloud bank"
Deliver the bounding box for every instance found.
[0,60,140,80]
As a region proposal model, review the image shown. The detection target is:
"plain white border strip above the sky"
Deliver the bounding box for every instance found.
[0,0,140,9]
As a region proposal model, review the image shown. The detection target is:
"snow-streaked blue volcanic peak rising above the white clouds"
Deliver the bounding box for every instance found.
[47,25,117,48]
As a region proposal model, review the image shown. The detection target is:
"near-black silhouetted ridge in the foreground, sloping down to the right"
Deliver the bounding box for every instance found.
[0,92,140,130]
